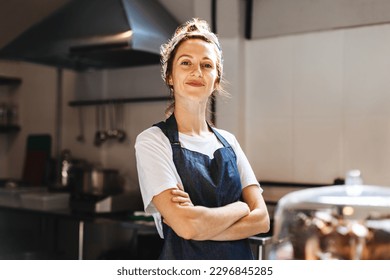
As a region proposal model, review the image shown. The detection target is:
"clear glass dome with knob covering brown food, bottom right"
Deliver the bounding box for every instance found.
[268,171,390,260]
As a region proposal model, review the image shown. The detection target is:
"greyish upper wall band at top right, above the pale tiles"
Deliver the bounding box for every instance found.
[252,0,390,39]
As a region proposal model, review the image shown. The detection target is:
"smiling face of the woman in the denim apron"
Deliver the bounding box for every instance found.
[168,39,218,104]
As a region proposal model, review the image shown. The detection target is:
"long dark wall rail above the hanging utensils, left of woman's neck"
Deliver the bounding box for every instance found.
[68,96,171,107]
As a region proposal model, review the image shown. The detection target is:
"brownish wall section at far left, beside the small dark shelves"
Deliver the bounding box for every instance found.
[0,61,59,178]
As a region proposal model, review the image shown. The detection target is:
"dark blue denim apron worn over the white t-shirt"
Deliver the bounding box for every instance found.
[155,114,253,260]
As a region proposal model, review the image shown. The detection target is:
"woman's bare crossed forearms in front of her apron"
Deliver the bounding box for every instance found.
[153,185,270,241]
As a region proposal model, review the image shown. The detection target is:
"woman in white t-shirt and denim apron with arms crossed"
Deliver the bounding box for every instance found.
[135,19,269,259]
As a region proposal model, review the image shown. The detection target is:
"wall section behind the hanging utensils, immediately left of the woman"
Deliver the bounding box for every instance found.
[63,66,168,192]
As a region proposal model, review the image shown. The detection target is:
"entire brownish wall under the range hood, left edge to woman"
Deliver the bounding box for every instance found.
[0,61,168,188]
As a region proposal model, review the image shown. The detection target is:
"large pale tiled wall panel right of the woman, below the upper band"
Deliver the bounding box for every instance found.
[244,25,390,185]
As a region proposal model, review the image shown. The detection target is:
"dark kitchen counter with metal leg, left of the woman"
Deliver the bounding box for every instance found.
[0,189,159,259]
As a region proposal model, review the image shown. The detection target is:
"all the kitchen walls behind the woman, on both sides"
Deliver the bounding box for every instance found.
[0,0,390,188]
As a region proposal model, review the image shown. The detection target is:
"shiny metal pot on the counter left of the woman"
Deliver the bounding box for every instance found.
[69,164,124,196]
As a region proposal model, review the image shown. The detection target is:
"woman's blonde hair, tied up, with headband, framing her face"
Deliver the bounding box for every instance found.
[160,18,228,114]
